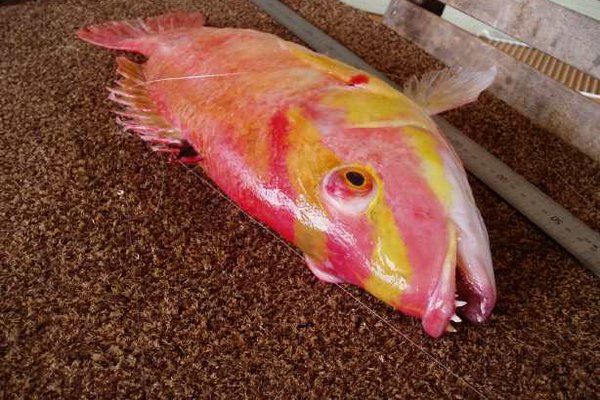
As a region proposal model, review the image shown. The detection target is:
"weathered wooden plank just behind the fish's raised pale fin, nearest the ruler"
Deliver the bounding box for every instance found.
[384,0,600,161]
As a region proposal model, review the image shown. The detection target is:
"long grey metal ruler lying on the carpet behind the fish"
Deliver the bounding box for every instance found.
[251,0,600,276]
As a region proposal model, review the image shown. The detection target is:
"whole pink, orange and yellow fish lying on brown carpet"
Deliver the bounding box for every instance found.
[77,11,496,338]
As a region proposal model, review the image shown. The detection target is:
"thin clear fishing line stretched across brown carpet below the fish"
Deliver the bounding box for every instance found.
[181,164,488,400]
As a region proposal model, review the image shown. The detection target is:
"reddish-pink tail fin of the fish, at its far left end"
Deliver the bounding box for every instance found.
[77,12,205,54]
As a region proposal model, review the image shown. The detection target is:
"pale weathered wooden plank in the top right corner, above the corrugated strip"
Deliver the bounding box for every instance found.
[432,0,600,78]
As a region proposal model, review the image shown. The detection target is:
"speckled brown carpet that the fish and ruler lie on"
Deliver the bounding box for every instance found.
[0,0,600,399]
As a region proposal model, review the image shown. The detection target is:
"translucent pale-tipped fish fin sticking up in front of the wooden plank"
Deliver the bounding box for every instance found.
[404,66,497,115]
